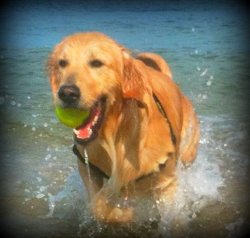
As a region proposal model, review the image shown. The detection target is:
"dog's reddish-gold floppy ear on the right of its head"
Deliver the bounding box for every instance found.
[122,52,147,102]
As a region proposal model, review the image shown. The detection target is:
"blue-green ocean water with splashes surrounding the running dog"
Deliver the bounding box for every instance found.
[0,1,250,237]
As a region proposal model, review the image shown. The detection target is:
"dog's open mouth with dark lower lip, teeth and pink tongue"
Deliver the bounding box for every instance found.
[73,97,106,144]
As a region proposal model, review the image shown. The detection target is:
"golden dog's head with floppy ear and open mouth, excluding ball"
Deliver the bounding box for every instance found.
[48,32,148,143]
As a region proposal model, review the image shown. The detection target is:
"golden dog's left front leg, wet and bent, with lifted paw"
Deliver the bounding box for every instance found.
[78,147,133,223]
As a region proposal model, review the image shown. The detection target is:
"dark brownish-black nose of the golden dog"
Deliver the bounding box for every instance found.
[58,84,80,104]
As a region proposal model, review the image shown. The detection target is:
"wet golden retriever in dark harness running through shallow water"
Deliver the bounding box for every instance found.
[48,32,199,223]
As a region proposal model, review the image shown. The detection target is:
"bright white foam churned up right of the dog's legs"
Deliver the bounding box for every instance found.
[159,141,223,234]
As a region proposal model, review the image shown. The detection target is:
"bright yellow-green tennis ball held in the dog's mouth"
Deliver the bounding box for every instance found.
[55,107,90,128]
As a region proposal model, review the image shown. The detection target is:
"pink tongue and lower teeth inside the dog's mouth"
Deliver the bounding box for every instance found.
[73,108,101,139]
